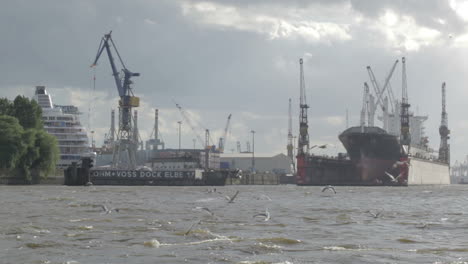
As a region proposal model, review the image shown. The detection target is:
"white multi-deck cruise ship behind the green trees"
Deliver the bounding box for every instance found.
[34,86,91,169]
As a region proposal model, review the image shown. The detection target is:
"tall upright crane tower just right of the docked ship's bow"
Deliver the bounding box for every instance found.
[400,57,411,154]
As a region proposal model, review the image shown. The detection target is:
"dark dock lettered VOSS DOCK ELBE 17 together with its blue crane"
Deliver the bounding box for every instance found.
[65,32,230,186]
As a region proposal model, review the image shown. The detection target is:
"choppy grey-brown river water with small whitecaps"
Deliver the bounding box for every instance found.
[0,185,468,263]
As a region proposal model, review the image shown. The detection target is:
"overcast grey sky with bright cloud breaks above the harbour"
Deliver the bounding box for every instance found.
[0,0,468,162]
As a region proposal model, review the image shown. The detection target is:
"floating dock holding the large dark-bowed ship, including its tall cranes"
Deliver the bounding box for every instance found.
[296,58,450,186]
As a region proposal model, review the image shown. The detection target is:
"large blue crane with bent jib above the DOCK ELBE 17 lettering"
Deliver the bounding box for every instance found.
[91,31,140,169]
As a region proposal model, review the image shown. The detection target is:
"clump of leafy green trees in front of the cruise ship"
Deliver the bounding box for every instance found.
[0,95,59,183]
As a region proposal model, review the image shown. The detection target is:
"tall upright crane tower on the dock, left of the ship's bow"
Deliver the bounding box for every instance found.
[298,58,309,155]
